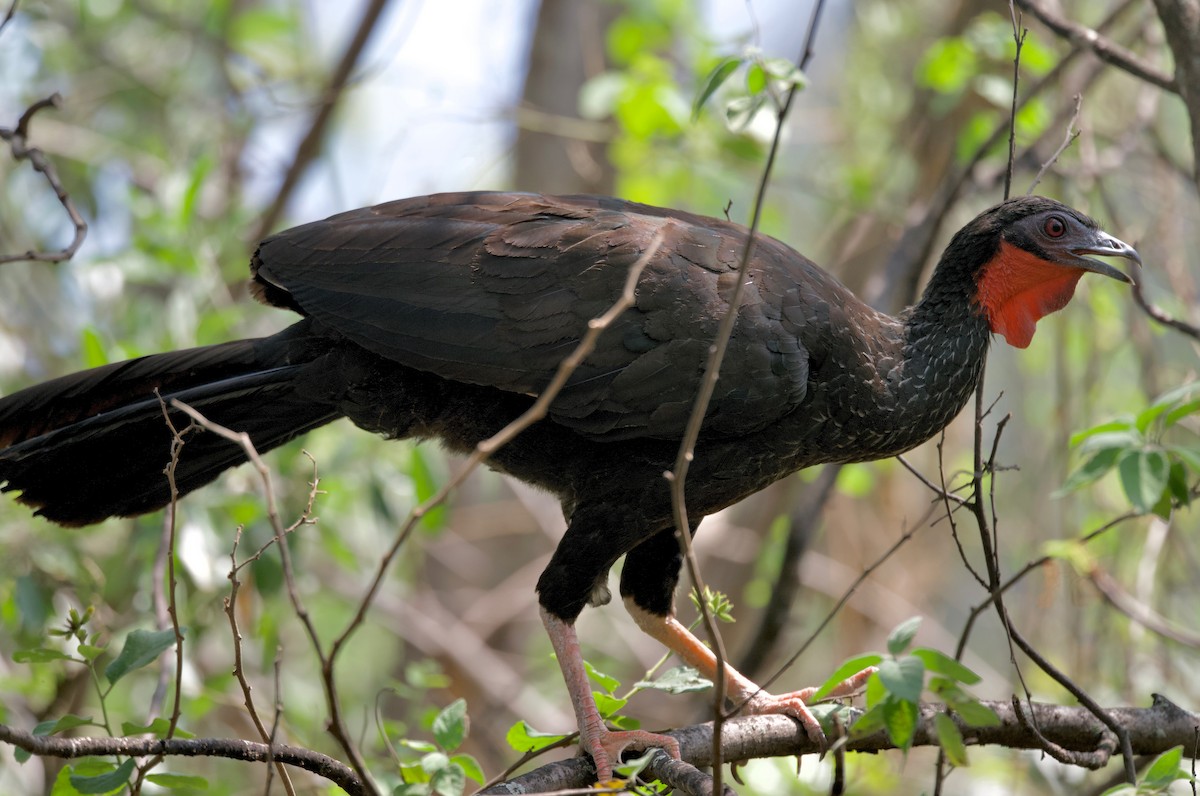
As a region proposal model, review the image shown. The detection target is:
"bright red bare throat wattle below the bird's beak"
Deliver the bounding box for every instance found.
[976,241,1084,348]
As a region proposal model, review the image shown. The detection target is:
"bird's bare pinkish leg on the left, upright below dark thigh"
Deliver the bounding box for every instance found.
[541,608,679,782]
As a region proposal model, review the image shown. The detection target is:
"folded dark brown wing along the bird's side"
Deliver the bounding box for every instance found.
[244,193,825,439]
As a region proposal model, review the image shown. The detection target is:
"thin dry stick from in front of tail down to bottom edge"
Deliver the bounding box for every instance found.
[170,400,374,792]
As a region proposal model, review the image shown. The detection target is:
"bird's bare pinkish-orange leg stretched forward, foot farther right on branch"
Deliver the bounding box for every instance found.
[625,597,875,746]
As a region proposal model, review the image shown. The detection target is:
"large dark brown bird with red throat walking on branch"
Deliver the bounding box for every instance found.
[0,193,1140,779]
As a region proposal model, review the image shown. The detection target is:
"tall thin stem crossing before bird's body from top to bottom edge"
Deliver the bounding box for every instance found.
[665,0,824,792]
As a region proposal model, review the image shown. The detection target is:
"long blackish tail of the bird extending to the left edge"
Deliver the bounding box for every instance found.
[0,321,341,526]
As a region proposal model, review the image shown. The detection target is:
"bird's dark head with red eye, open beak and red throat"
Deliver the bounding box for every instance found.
[960,196,1141,348]
